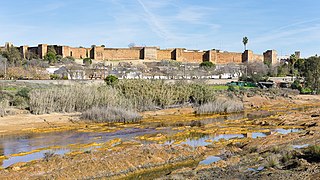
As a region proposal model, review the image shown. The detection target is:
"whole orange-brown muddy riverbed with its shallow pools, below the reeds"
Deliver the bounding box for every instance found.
[0,96,320,179]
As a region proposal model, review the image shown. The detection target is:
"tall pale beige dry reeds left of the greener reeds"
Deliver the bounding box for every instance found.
[30,85,131,114]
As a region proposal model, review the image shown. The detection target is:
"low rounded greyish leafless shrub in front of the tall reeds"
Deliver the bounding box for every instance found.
[82,107,142,123]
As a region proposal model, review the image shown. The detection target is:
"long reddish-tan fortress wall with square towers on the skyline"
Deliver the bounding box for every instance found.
[0,43,278,64]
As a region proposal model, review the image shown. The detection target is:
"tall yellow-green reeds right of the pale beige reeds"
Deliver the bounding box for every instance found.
[116,80,215,111]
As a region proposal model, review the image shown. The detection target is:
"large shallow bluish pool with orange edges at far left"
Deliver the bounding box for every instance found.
[0,128,172,168]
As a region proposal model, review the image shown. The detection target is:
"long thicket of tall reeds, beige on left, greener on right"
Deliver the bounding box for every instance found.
[29,80,215,114]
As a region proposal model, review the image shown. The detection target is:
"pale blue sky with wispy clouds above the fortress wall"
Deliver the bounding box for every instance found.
[0,0,320,56]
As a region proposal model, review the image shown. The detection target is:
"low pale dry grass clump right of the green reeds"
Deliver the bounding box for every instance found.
[196,98,244,115]
